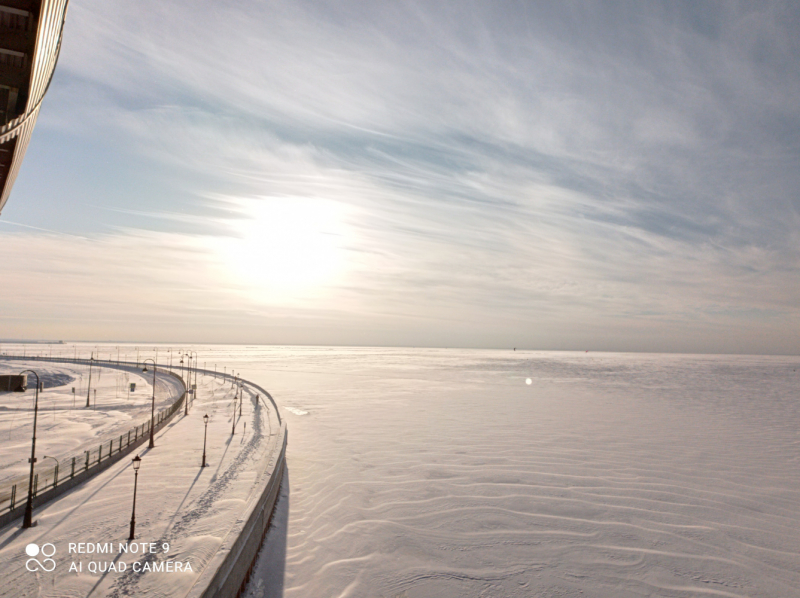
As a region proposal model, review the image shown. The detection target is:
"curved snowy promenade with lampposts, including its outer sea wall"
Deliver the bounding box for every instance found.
[0,358,287,598]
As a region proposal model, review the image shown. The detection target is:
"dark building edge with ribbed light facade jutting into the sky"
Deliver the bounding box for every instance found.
[0,0,69,212]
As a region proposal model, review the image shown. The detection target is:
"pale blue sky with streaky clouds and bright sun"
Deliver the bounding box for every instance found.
[0,0,800,354]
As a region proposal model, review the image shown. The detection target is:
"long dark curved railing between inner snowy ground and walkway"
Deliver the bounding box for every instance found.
[0,355,186,521]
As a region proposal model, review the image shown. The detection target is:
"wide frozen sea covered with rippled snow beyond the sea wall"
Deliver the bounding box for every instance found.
[4,346,800,598]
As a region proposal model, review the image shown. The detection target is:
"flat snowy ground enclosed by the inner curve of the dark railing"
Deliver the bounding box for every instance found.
[0,357,183,487]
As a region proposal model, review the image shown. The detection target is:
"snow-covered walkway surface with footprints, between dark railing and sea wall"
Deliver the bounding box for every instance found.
[0,366,280,597]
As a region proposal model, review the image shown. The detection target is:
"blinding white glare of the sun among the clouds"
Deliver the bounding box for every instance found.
[217,197,345,300]
